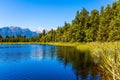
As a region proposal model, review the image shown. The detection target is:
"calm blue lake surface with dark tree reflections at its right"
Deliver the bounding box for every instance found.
[0,44,100,80]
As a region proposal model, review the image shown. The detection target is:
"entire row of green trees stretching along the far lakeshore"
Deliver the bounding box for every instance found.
[0,0,120,42]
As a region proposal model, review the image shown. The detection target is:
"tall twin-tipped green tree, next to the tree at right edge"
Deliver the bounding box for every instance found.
[98,5,112,41]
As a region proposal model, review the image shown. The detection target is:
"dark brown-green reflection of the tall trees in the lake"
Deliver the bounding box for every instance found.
[57,47,100,80]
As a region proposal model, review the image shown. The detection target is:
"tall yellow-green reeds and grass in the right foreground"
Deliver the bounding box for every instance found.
[89,42,120,80]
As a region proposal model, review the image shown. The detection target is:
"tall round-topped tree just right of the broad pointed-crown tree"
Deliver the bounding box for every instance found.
[86,10,99,42]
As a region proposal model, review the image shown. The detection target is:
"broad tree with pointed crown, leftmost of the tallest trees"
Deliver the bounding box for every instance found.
[73,8,89,42]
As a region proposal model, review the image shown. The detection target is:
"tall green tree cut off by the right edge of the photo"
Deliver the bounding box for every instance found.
[108,0,120,41]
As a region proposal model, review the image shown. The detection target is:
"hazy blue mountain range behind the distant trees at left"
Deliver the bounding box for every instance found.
[0,27,38,38]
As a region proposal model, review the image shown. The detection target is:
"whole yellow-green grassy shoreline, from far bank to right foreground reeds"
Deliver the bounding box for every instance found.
[0,41,120,79]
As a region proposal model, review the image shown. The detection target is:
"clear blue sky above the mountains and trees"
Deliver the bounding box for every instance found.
[0,0,116,30]
